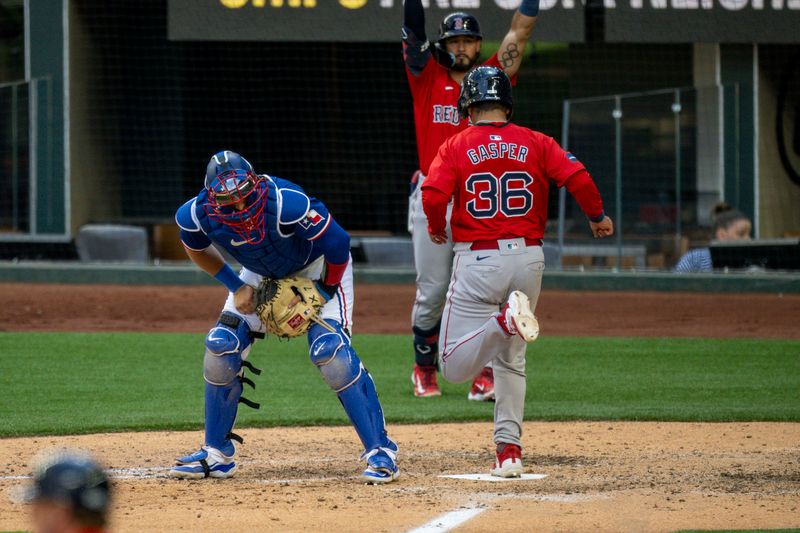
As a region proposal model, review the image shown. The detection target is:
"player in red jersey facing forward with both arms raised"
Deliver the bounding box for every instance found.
[403,0,539,401]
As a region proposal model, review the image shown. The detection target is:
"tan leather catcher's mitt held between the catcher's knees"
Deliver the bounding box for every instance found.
[255,277,334,339]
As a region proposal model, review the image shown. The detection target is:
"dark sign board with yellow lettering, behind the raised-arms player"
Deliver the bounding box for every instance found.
[168,0,584,42]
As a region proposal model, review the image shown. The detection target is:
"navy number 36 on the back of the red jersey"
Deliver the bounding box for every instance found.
[465,171,533,218]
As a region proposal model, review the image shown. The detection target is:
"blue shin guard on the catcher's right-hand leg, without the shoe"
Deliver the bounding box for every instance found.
[308,323,391,451]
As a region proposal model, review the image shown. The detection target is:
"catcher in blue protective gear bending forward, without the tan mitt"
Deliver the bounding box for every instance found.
[170,150,400,483]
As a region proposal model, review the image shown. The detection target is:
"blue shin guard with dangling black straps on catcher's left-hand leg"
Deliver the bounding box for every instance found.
[203,313,259,455]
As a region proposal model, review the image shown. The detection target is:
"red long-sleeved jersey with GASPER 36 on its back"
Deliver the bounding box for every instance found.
[422,122,603,242]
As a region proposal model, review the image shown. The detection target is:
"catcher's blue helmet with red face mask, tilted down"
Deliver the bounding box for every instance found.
[204,150,267,244]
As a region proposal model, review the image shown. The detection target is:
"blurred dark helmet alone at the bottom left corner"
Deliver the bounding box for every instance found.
[23,450,111,523]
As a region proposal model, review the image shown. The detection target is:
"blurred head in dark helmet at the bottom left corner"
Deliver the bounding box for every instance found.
[23,450,111,533]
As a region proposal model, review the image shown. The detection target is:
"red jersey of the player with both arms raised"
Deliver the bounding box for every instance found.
[406,54,516,176]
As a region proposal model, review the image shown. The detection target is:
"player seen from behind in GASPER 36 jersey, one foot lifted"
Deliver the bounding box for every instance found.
[422,66,614,477]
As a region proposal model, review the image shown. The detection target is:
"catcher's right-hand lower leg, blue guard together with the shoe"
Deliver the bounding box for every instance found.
[308,321,399,483]
